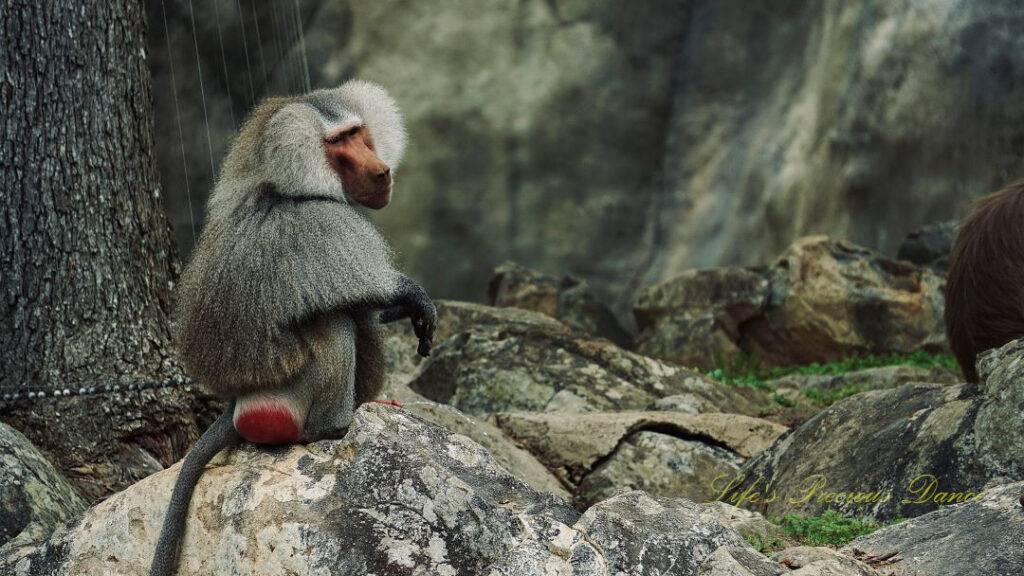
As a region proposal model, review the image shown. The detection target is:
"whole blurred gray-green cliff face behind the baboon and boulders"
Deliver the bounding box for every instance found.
[151,0,1024,310]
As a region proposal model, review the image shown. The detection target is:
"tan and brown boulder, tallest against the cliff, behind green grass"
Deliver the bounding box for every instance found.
[743,237,945,365]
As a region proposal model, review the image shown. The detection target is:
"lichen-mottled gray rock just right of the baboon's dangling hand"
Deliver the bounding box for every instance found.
[410,317,721,414]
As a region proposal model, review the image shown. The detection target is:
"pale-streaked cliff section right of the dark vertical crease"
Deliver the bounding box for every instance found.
[658,1,1024,274]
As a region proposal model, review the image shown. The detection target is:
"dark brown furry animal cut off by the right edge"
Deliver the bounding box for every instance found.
[946,180,1024,382]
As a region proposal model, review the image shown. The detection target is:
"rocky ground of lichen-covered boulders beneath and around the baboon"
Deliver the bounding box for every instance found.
[0,237,1024,576]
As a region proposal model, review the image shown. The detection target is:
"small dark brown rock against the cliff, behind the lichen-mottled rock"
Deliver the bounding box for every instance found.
[487,262,633,347]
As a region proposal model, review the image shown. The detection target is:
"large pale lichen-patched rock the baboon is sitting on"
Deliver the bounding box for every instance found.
[8,404,579,576]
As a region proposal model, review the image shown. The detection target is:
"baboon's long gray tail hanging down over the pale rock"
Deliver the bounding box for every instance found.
[150,402,239,576]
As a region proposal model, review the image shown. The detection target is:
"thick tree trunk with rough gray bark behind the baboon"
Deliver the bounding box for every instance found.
[0,0,220,497]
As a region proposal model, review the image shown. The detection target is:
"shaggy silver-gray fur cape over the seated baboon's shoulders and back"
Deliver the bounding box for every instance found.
[178,186,400,392]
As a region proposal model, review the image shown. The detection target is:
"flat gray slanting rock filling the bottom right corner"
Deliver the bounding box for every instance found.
[844,482,1024,576]
